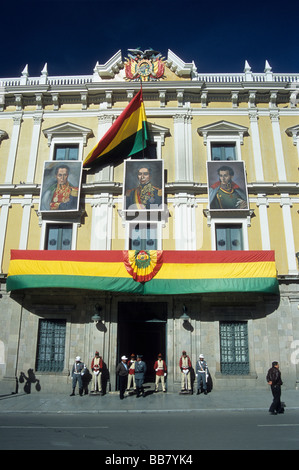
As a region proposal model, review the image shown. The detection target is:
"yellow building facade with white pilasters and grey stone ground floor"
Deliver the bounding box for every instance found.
[0,50,299,393]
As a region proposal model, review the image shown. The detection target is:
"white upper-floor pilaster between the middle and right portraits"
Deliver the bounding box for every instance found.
[173,114,193,181]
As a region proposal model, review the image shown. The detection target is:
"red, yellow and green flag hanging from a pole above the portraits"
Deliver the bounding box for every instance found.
[83,90,148,167]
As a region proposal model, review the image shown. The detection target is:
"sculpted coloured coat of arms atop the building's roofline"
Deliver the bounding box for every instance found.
[124,48,165,82]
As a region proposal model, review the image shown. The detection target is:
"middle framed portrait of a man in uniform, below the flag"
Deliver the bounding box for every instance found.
[123,159,164,212]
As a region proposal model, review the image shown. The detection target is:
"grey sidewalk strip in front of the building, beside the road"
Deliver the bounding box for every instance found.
[0,389,299,414]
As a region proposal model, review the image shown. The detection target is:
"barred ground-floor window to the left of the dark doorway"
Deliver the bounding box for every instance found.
[35,320,66,372]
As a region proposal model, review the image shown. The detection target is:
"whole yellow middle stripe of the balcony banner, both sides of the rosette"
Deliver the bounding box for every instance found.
[8,260,276,279]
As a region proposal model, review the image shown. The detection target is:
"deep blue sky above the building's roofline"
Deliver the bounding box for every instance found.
[0,0,299,78]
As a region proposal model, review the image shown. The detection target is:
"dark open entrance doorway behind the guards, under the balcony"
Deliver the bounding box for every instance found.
[118,302,167,382]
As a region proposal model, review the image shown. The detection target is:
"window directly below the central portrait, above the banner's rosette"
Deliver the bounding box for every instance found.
[129,224,157,250]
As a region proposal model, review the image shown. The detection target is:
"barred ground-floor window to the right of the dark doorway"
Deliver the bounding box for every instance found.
[220,322,249,375]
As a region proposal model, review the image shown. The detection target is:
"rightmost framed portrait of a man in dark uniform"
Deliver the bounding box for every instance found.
[207,161,249,211]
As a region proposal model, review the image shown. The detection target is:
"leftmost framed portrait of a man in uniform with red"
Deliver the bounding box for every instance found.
[39,160,82,213]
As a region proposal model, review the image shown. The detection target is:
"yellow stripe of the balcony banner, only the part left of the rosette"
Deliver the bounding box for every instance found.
[8,260,131,278]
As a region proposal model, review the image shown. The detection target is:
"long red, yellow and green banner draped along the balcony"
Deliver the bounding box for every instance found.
[7,250,278,295]
